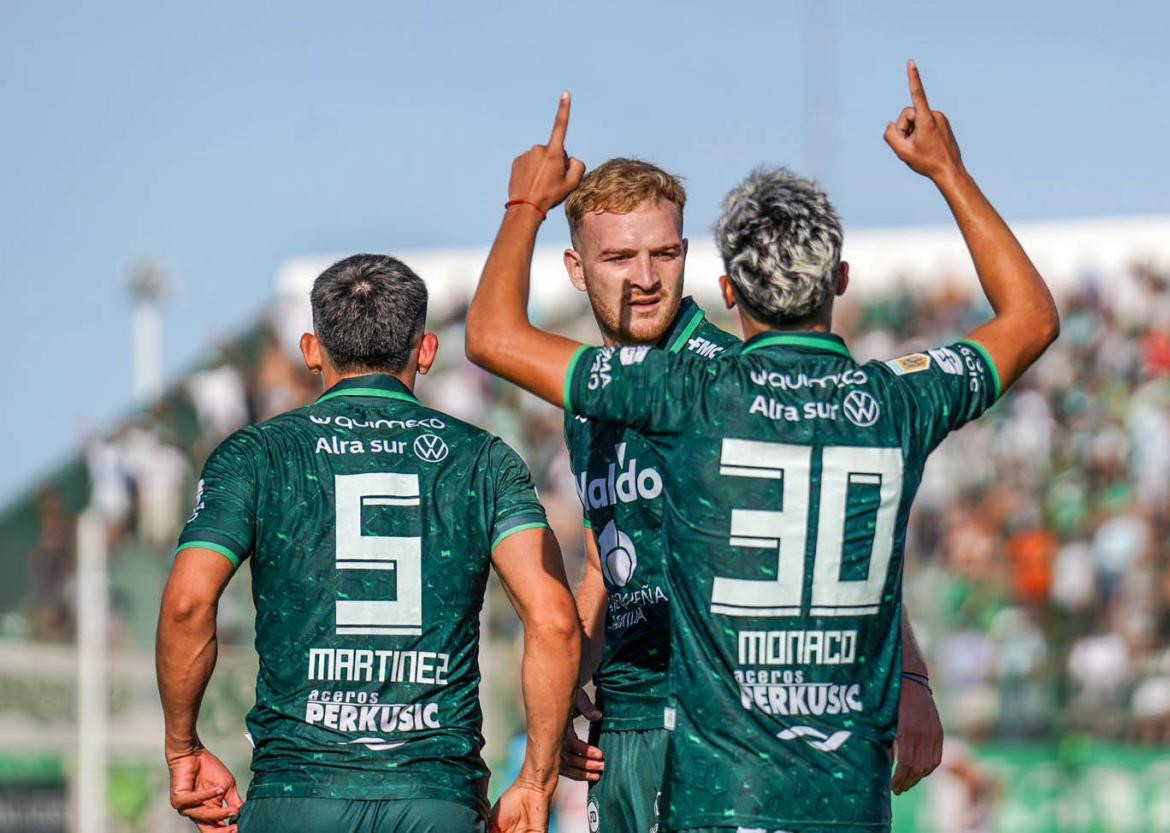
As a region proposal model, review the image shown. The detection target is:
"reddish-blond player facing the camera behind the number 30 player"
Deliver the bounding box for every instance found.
[562,159,942,833]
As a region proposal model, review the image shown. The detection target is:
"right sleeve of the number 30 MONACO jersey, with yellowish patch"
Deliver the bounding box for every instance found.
[882,340,1002,450]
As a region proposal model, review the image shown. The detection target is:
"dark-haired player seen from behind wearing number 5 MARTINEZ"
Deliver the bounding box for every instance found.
[157,255,580,833]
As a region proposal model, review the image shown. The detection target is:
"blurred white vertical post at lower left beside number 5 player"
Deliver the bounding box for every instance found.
[73,508,110,833]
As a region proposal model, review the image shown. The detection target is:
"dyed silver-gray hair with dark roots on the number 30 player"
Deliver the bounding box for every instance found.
[715,167,842,324]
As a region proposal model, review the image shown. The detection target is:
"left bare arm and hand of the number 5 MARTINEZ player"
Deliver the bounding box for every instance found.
[154,549,243,833]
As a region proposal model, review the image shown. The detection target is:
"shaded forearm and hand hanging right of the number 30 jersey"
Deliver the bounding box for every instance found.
[890,610,943,796]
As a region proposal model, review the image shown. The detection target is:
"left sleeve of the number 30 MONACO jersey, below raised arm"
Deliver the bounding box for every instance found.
[564,346,717,434]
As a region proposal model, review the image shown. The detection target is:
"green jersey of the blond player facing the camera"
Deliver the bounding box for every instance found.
[565,298,739,730]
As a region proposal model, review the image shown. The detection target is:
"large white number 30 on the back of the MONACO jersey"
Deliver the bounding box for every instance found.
[711,439,903,617]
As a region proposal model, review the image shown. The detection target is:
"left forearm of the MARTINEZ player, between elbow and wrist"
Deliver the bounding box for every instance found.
[156,603,218,758]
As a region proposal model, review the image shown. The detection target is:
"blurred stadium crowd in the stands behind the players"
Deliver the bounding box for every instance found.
[16,257,1170,745]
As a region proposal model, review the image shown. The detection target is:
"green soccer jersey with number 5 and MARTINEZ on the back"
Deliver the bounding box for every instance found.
[179,374,546,813]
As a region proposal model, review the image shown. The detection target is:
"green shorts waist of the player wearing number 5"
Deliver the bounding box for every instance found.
[240,798,486,833]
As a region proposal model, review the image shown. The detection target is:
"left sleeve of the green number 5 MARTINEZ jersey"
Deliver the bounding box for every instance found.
[176,428,262,566]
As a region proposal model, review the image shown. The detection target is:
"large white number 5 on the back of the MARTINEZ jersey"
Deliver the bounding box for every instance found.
[333,473,422,636]
